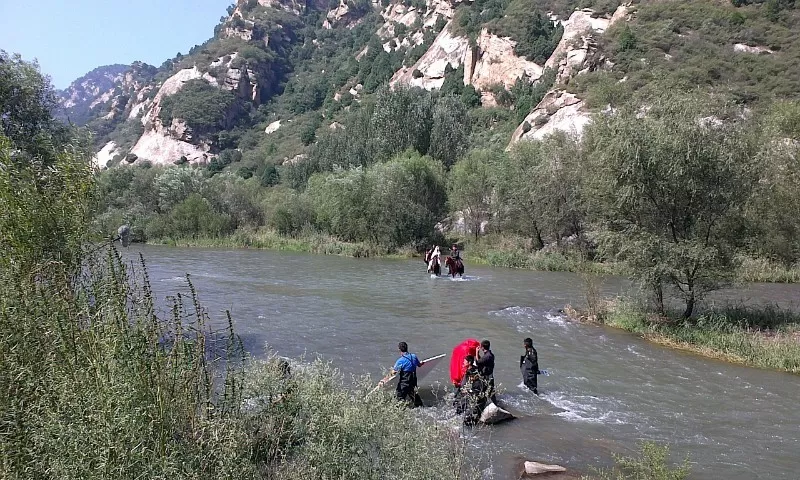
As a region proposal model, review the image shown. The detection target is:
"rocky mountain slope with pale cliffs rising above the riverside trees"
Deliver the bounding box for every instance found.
[62,0,800,168]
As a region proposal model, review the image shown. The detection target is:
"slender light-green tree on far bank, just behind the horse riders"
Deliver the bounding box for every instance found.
[449,150,494,239]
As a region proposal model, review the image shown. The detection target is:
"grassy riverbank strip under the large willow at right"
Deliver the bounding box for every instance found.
[566,301,800,374]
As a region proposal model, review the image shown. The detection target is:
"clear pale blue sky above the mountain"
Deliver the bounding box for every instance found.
[0,0,233,88]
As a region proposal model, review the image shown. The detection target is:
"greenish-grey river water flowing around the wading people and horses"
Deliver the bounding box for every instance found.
[124,245,800,479]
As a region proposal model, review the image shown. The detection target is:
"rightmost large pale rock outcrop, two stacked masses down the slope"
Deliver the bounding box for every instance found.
[511,5,629,144]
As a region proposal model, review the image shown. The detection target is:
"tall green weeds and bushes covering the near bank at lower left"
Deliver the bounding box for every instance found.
[0,249,471,479]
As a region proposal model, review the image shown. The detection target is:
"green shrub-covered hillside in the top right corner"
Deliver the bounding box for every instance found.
[604,0,800,104]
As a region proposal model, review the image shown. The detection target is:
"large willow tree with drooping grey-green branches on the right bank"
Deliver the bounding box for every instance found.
[586,94,758,318]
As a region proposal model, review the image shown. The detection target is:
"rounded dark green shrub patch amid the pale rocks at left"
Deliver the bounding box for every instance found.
[159,79,236,133]
